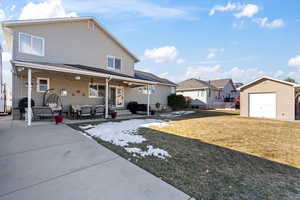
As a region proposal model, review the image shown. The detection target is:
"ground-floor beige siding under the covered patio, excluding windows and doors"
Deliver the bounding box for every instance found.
[13,70,171,111]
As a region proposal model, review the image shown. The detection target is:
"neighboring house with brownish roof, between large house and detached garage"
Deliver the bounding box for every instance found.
[176,78,237,108]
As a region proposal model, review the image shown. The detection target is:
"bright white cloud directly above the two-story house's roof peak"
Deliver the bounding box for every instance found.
[19,0,77,19]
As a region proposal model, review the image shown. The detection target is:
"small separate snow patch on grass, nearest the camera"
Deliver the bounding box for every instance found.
[125,145,171,159]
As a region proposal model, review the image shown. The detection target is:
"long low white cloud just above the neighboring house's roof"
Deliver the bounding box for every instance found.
[184,65,265,83]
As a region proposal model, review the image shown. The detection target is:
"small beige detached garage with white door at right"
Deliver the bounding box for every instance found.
[239,77,300,121]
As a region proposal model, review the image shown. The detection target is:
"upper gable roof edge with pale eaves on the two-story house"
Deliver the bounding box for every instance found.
[2,17,139,62]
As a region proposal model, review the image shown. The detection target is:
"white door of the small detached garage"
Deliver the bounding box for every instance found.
[249,93,276,119]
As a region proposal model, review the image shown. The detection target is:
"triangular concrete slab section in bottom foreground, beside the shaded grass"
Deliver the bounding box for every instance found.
[0,158,189,200]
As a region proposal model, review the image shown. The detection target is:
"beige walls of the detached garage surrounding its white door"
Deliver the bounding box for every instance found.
[240,79,295,121]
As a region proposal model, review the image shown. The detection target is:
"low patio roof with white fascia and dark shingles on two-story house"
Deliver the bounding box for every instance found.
[12,60,176,86]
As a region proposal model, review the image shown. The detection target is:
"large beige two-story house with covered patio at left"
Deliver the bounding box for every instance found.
[2,17,176,122]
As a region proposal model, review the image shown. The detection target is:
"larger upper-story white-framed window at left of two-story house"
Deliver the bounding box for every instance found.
[19,33,45,56]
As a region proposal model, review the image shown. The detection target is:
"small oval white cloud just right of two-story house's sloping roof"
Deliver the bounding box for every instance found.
[144,46,178,63]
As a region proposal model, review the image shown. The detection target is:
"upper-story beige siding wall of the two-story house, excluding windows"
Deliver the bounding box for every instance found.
[12,21,134,75]
